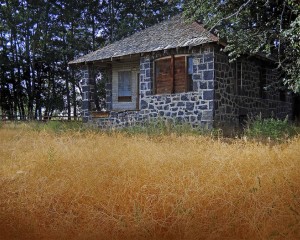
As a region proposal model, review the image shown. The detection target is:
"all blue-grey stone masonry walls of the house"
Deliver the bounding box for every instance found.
[81,45,292,128]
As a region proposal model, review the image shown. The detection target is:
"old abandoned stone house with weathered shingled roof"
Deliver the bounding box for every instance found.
[70,15,292,128]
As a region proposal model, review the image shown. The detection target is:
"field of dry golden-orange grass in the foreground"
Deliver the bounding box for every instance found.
[0,126,300,240]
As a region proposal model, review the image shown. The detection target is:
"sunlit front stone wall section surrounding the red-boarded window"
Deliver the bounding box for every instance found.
[140,46,214,128]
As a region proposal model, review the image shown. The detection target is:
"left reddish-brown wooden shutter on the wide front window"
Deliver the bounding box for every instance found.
[155,58,173,94]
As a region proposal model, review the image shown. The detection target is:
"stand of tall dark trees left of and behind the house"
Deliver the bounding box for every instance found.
[0,0,180,120]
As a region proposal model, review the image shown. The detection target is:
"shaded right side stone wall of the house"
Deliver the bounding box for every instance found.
[214,51,292,127]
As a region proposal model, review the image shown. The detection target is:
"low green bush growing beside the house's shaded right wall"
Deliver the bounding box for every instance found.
[245,118,299,140]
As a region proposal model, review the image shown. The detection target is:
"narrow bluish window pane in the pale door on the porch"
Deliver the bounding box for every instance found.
[118,71,132,102]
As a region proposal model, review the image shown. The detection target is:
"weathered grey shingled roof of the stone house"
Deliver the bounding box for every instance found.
[69,15,218,64]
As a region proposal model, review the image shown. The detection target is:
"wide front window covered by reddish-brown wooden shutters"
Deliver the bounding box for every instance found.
[155,56,193,94]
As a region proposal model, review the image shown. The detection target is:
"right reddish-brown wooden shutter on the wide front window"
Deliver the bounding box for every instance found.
[174,56,188,93]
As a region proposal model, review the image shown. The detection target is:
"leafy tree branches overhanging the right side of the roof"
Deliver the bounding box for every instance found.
[184,0,300,93]
